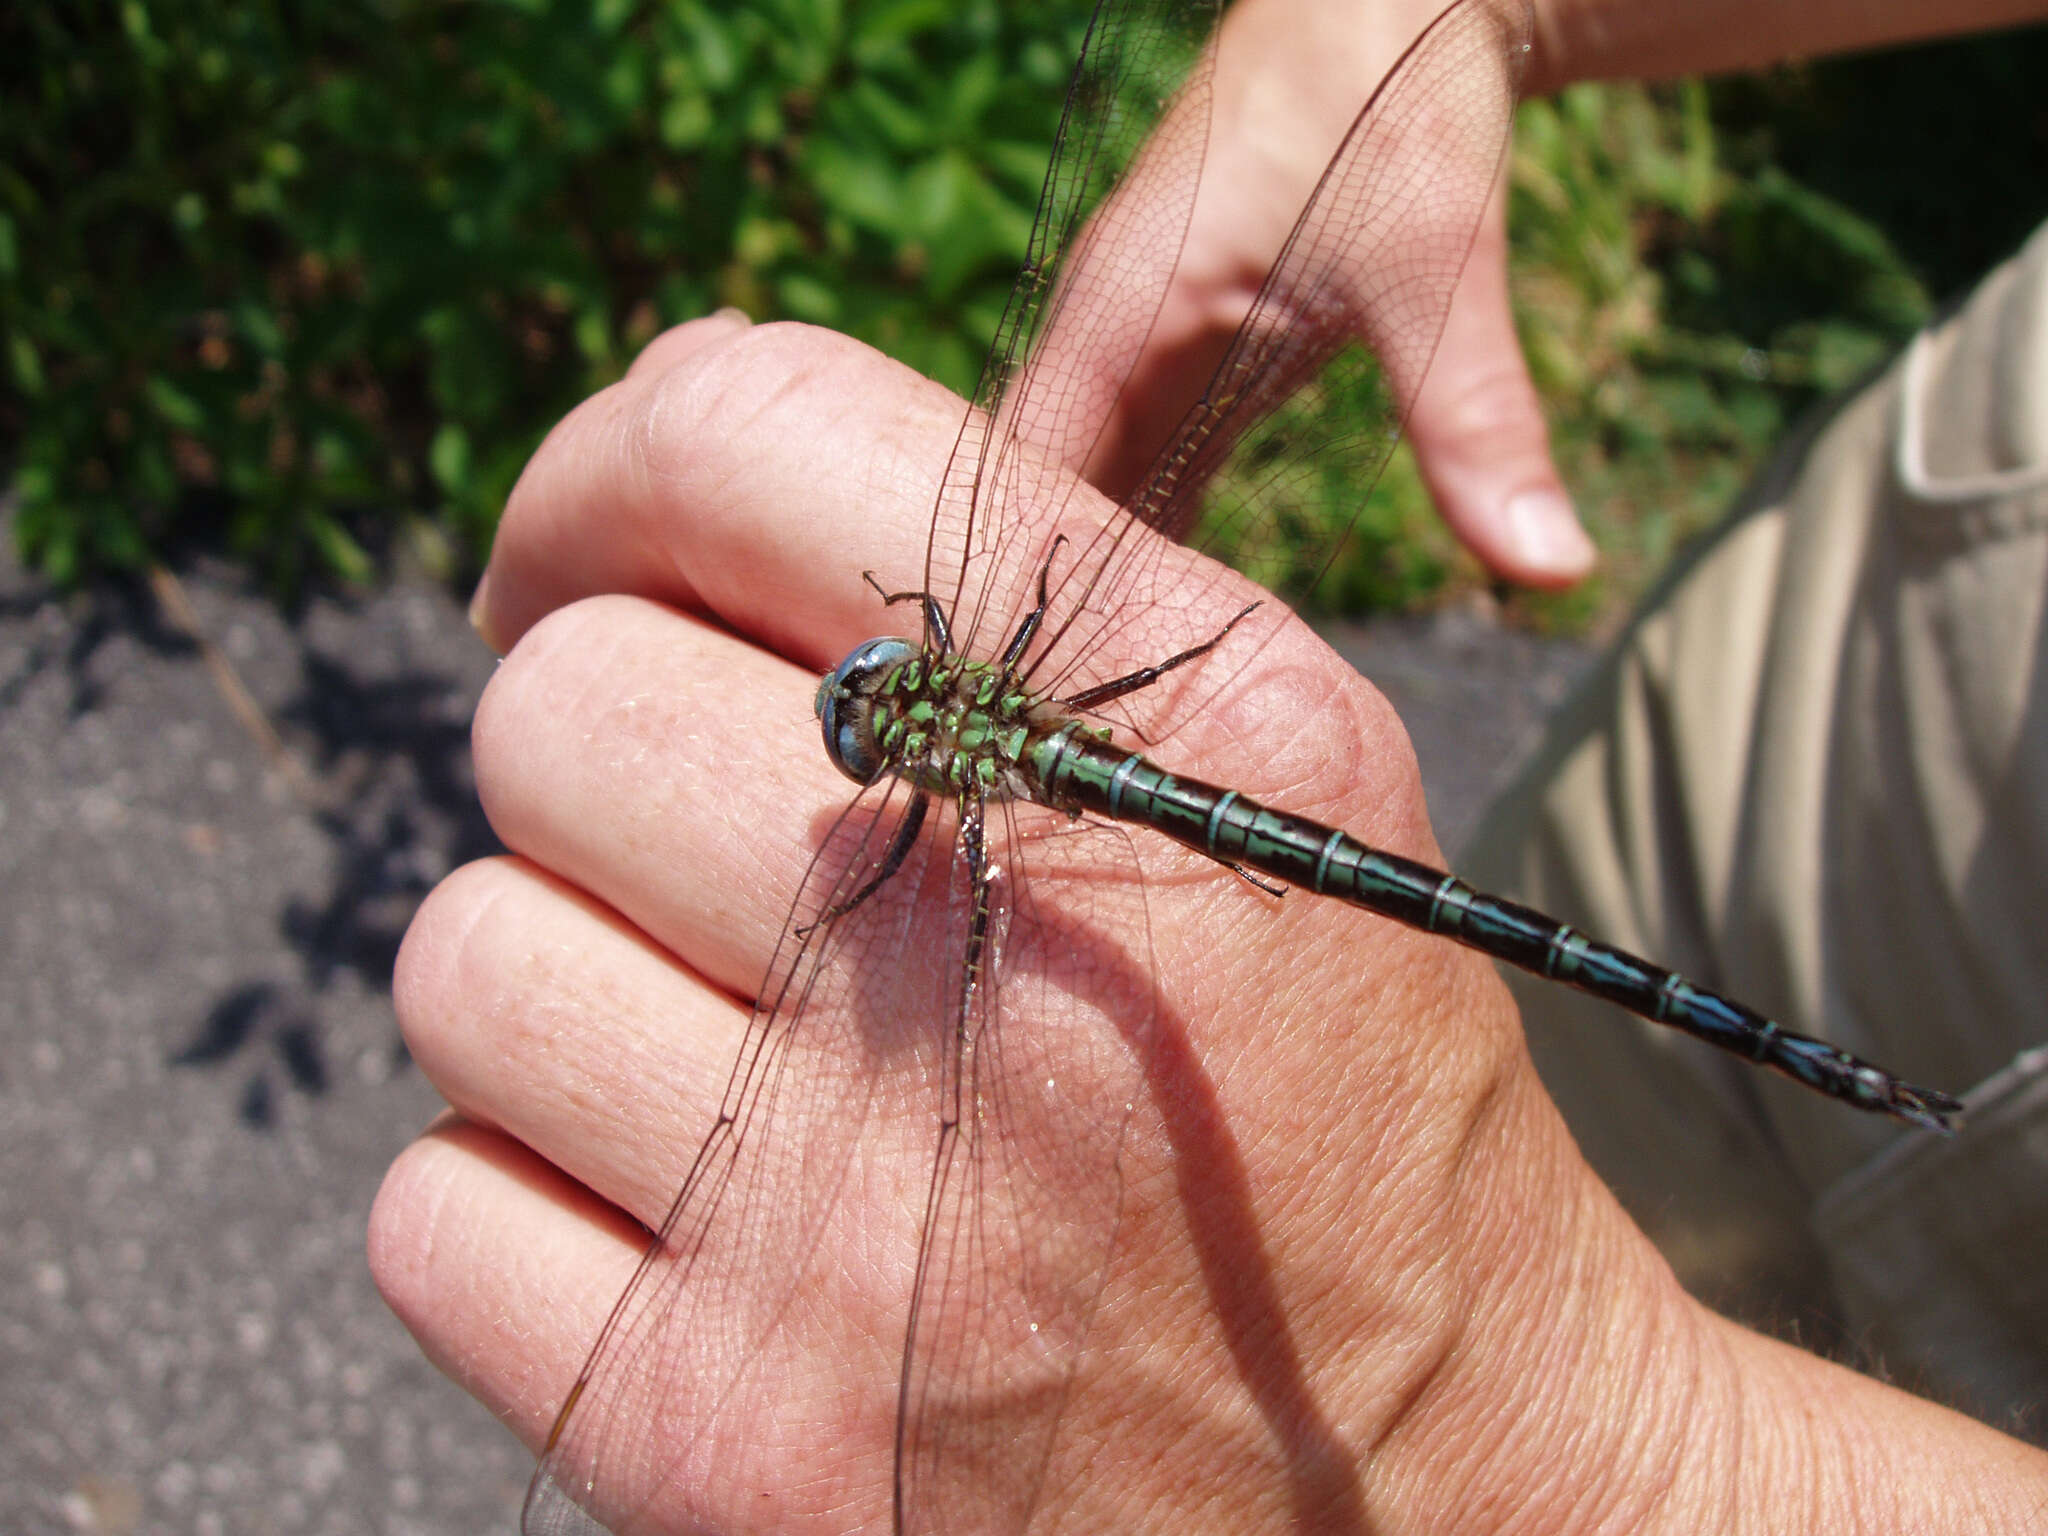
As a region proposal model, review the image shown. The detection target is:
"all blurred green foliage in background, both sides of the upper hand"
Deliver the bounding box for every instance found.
[0,0,2048,623]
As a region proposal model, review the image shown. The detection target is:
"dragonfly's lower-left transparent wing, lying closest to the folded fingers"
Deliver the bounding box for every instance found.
[522,778,966,1536]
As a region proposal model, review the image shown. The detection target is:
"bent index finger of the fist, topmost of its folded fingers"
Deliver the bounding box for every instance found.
[471,311,963,670]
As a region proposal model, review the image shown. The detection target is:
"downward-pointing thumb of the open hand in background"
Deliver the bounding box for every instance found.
[1409,186,1597,588]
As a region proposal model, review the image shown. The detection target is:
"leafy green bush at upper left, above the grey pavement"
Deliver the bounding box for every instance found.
[0,0,1087,590]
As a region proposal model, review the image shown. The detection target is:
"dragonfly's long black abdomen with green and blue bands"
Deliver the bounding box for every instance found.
[1022,721,1962,1130]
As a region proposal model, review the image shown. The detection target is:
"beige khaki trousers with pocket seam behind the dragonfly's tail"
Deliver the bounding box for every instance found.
[1464,219,2048,1438]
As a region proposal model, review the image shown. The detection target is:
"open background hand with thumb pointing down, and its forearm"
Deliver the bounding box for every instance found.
[1114,0,2042,588]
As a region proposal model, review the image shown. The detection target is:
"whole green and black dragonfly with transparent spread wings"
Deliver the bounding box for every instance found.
[522,0,1960,1536]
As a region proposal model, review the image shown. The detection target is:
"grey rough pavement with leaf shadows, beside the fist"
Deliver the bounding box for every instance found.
[0,524,1583,1536]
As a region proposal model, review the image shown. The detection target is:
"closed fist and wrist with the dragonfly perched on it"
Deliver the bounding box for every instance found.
[371,317,2048,1530]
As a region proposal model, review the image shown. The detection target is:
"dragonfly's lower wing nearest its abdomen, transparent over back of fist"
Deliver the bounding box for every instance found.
[897,805,1155,1534]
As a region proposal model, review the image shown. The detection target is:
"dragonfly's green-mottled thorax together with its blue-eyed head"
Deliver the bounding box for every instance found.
[815,635,1038,797]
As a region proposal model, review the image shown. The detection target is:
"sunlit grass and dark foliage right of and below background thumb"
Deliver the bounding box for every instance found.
[1300,29,2048,629]
